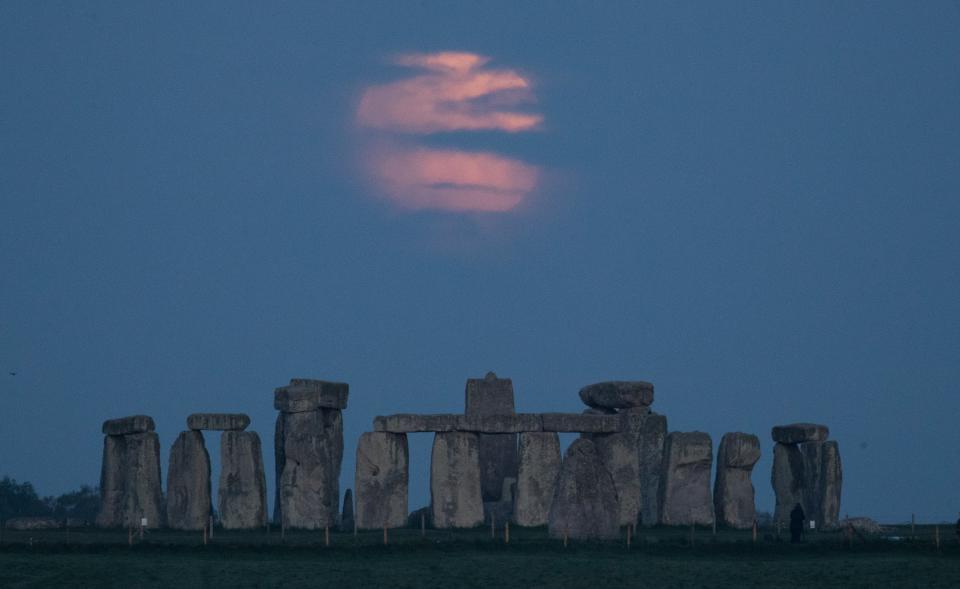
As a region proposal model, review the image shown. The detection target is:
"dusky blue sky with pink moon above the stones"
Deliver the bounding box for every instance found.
[0,1,960,522]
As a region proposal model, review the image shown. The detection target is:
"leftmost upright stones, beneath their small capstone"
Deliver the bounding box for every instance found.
[97,432,162,528]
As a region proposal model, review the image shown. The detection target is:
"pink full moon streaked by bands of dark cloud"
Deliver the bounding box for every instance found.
[356,52,543,212]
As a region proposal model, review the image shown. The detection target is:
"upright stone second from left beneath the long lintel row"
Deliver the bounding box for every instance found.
[430,432,483,529]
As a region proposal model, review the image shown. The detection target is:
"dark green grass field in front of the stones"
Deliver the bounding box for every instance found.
[0,526,960,589]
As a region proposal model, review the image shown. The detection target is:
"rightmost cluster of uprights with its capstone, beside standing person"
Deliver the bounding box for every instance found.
[771,423,843,529]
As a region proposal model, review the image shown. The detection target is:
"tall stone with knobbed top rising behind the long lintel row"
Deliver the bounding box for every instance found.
[464,372,518,502]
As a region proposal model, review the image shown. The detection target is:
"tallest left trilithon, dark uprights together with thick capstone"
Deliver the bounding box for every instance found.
[273,379,349,529]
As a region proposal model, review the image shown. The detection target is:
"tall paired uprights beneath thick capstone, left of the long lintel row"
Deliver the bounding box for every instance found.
[274,409,343,529]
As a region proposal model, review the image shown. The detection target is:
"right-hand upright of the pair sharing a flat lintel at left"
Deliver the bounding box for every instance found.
[217,431,267,530]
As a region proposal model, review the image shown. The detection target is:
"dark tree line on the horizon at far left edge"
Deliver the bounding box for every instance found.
[0,477,100,522]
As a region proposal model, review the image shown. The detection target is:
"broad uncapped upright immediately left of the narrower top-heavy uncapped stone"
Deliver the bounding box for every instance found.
[660,432,713,525]
